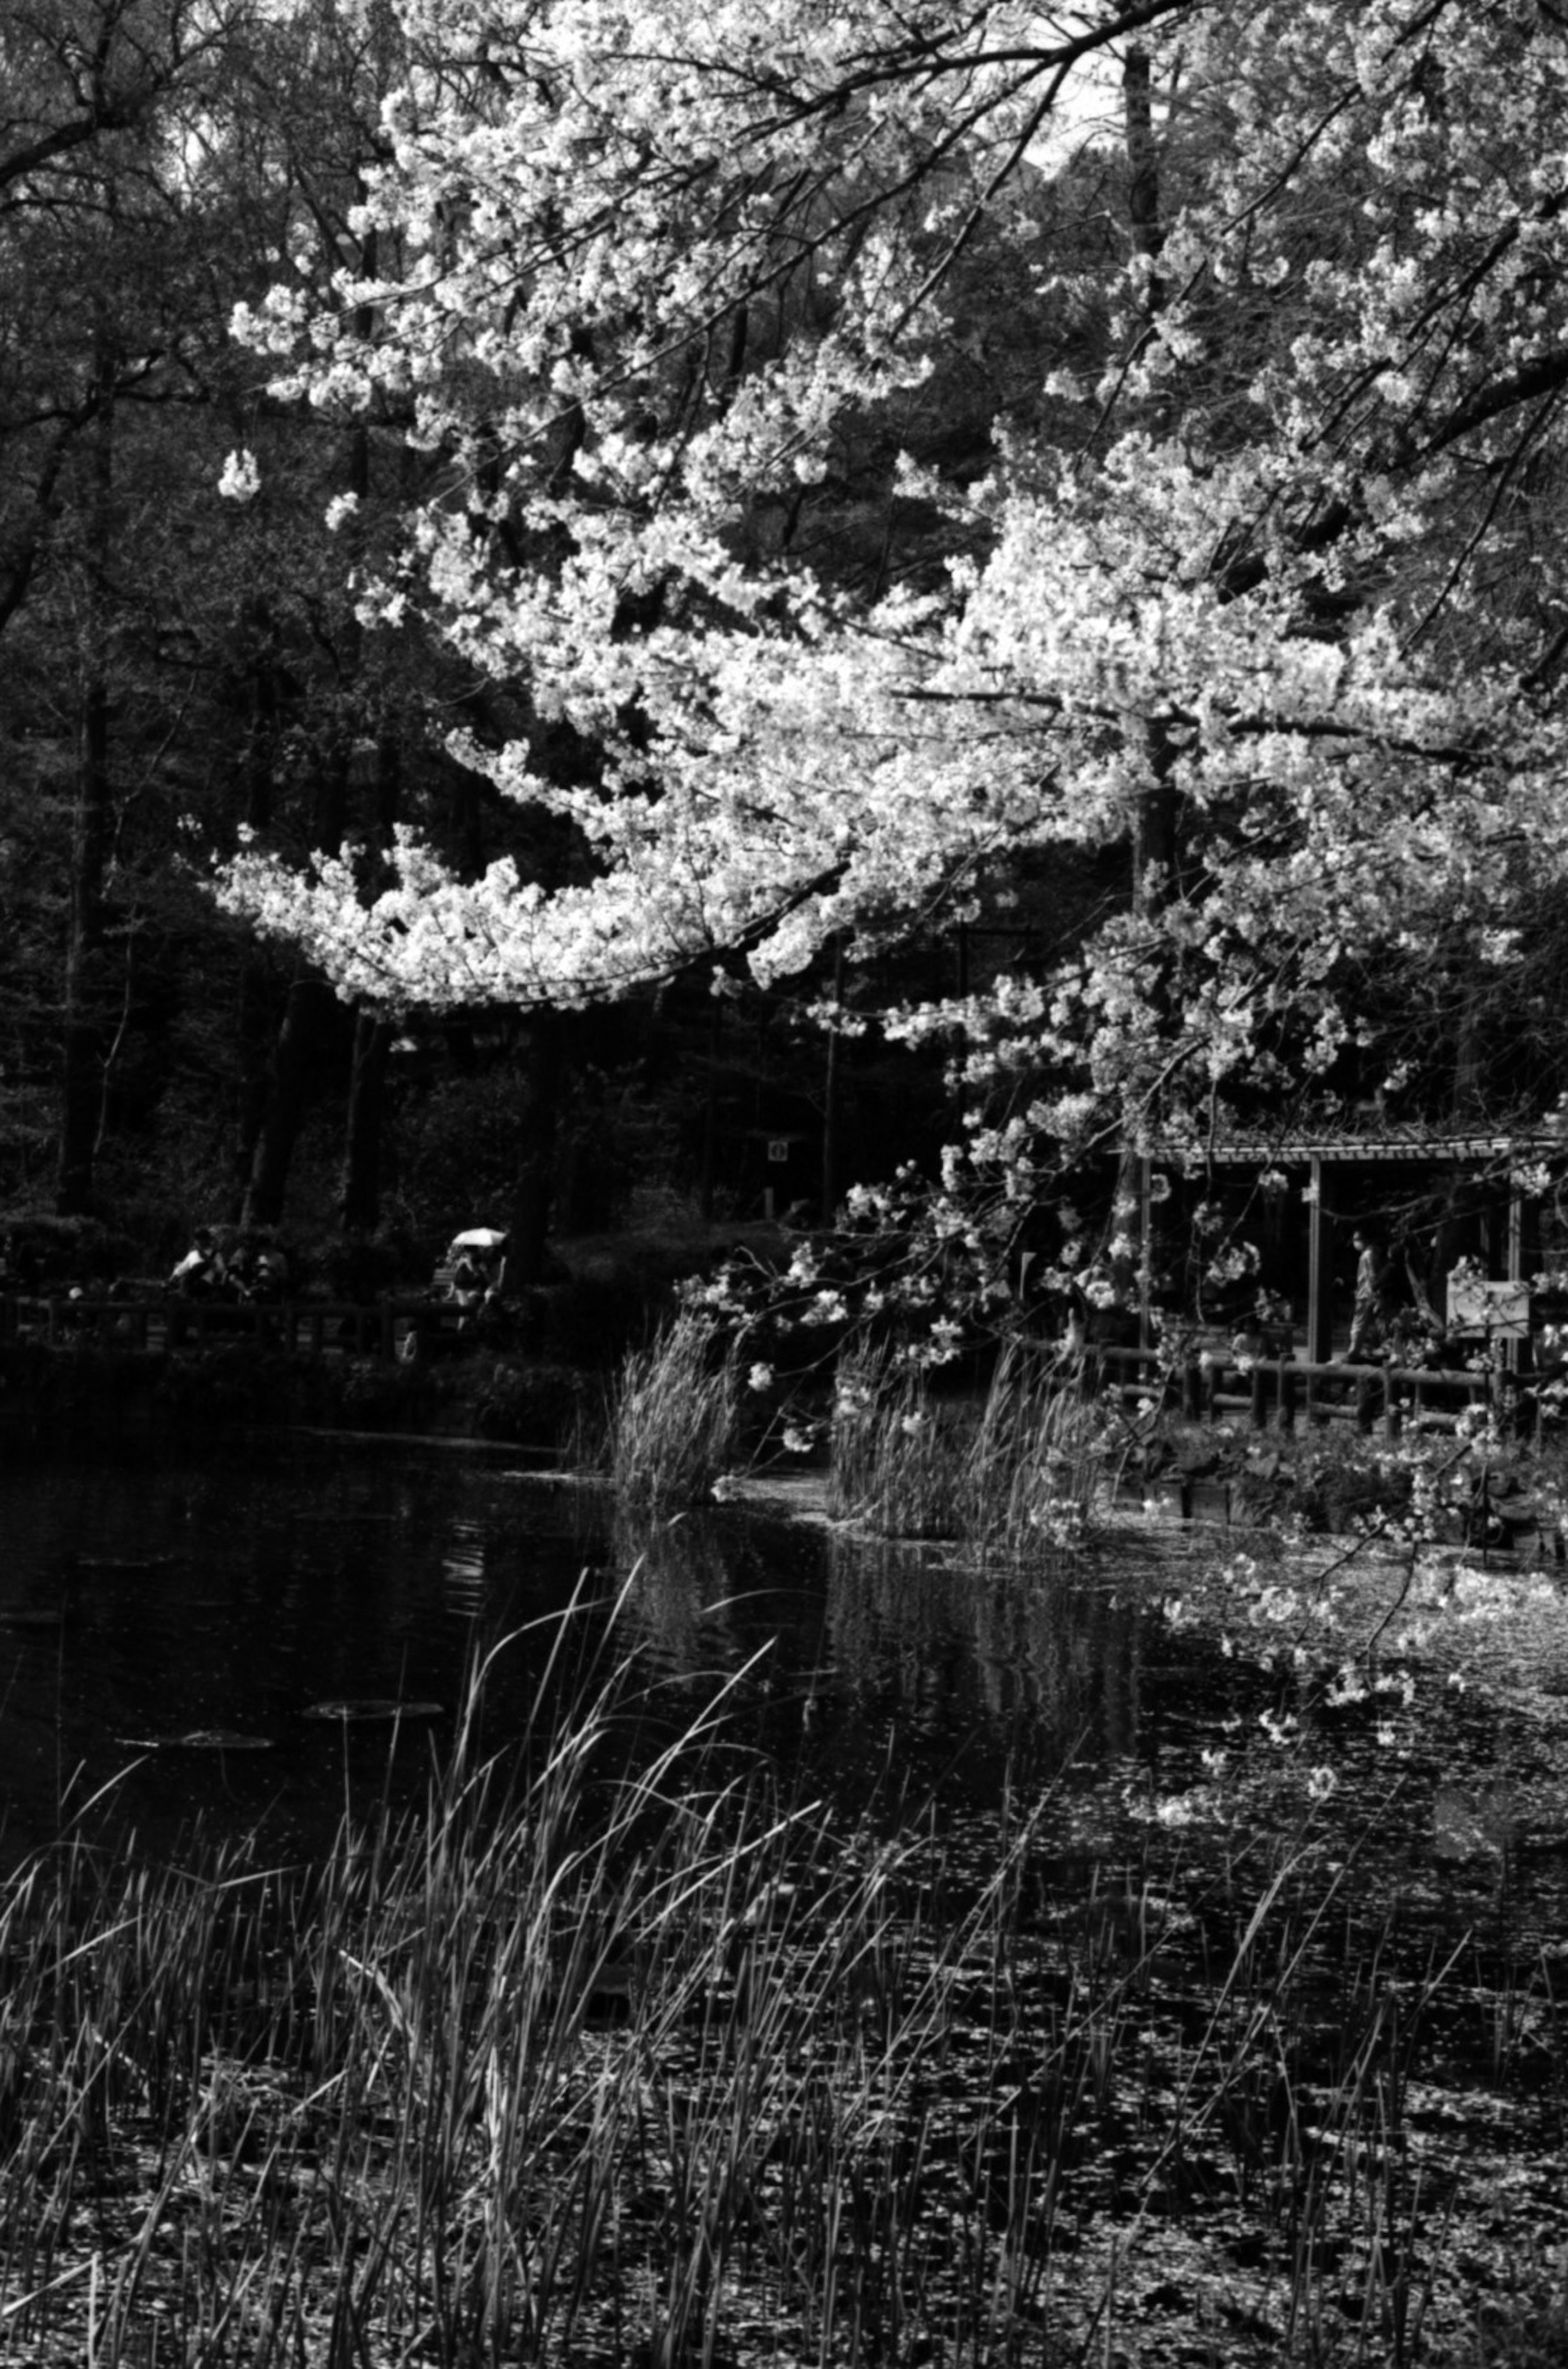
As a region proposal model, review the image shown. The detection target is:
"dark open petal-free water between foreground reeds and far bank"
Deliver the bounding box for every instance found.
[0,1440,1172,1862]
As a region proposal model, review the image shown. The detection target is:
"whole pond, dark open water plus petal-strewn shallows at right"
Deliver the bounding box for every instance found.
[0,1440,1568,2364]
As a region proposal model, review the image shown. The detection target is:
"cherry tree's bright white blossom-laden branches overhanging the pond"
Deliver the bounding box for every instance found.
[220,0,1568,1298]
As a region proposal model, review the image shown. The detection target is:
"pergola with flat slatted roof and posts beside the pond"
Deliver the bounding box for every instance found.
[1142,1128,1568,1364]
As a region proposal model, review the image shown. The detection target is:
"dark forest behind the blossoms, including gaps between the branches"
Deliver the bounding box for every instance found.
[0,0,1568,1308]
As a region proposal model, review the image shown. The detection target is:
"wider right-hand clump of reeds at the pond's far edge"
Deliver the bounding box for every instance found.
[829,1341,1106,1561]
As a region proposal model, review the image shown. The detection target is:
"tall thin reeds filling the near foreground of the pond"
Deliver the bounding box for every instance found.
[0,1620,1554,2369]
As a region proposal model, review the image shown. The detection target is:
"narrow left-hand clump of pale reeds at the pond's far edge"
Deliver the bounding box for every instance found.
[604,1310,742,1514]
